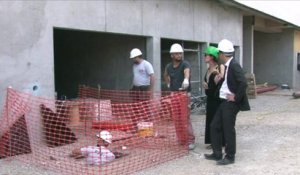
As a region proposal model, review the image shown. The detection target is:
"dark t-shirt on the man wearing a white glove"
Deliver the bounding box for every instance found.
[166,60,191,92]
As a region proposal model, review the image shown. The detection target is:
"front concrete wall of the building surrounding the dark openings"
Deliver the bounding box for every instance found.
[0,0,242,106]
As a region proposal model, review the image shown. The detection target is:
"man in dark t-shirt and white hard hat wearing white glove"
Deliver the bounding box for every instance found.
[164,43,195,150]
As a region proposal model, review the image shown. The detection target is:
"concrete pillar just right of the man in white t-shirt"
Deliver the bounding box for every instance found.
[146,37,161,91]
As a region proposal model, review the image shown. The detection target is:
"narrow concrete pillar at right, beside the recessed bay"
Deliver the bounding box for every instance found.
[242,16,254,73]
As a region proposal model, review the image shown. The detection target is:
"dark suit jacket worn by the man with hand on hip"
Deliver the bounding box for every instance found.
[227,59,250,111]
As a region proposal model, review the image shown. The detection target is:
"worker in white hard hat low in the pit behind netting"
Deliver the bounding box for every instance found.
[71,130,116,165]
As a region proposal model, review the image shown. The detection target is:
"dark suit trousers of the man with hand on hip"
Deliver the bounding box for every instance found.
[210,100,239,158]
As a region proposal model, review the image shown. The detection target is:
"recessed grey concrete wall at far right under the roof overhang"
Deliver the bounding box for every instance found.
[254,30,294,87]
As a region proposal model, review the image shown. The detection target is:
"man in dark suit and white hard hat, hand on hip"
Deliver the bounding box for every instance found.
[204,39,250,165]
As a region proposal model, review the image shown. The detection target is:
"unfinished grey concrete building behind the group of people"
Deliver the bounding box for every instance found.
[0,0,300,106]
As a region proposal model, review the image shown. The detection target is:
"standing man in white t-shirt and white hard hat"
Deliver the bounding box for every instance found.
[130,48,155,101]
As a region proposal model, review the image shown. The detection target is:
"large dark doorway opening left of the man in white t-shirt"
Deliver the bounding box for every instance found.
[53,28,146,99]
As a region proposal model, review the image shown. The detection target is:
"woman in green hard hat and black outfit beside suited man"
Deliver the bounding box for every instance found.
[203,46,225,149]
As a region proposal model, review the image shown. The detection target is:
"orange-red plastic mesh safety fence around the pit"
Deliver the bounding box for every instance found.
[0,86,189,175]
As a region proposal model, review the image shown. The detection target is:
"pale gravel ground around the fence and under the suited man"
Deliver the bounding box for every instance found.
[0,90,300,175]
